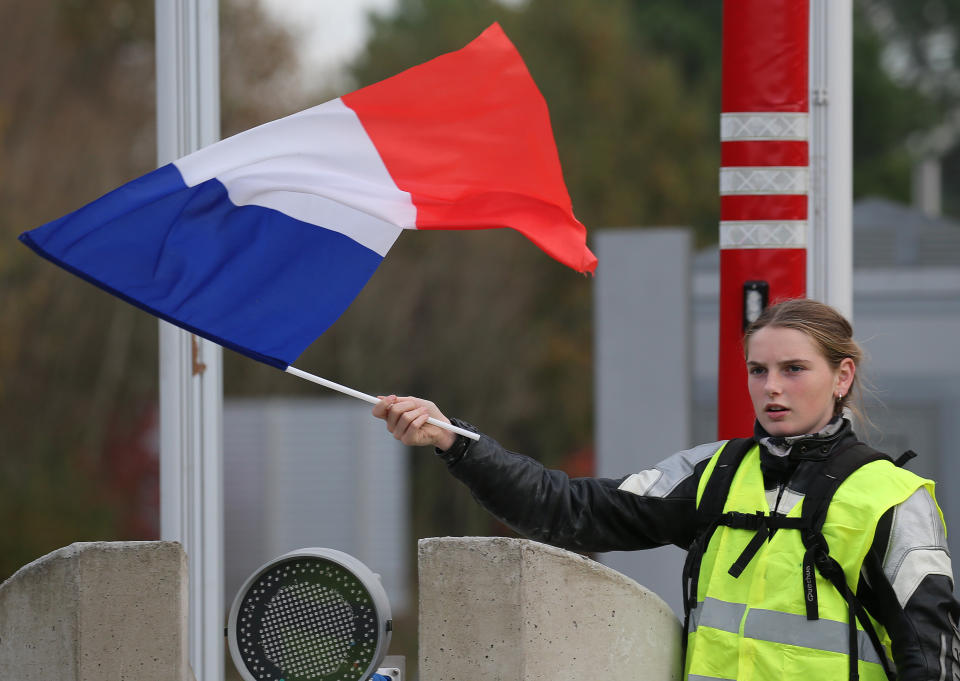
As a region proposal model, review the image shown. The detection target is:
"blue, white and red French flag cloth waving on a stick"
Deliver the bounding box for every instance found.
[20,24,597,369]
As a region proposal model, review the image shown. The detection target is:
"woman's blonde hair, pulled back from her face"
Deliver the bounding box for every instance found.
[743,298,865,420]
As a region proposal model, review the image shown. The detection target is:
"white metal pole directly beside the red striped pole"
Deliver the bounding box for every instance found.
[807,0,853,319]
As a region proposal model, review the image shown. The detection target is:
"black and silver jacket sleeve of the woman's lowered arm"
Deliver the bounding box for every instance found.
[864,488,960,681]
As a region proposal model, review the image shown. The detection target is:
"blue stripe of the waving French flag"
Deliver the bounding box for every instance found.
[20,164,383,369]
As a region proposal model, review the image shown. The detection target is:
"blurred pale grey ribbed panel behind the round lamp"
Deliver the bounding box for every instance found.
[224,397,411,612]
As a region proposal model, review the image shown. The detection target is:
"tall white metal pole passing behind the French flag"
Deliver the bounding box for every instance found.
[154,0,224,681]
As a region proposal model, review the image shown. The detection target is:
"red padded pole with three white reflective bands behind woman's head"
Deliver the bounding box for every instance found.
[717,0,810,438]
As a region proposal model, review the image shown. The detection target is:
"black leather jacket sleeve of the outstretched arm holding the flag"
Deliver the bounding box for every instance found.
[438,421,720,551]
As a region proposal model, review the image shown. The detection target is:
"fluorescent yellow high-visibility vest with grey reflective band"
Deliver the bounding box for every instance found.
[685,446,942,681]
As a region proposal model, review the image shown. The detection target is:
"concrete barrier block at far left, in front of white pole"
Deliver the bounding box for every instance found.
[0,542,193,681]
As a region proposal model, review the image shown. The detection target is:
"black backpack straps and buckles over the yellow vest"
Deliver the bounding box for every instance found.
[683,438,916,681]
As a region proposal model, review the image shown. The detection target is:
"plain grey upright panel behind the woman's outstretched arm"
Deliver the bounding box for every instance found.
[594,229,692,614]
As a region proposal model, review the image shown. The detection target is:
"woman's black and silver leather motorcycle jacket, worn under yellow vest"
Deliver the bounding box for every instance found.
[437,420,960,681]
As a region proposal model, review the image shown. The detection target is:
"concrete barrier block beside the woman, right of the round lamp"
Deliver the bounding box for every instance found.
[419,537,682,681]
